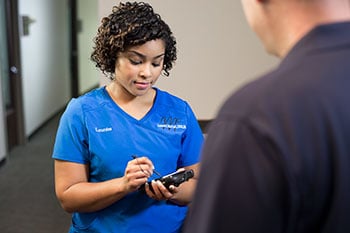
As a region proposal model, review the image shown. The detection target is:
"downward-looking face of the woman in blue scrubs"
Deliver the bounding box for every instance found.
[115,39,165,96]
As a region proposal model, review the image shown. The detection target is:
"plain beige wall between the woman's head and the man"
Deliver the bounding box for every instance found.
[99,0,278,120]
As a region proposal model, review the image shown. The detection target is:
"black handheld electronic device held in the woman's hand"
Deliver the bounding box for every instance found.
[140,169,194,192]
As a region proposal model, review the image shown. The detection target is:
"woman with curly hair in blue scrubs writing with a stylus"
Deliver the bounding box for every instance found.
[53,2,203,233]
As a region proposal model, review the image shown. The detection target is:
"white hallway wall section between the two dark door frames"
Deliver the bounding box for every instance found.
[19,0,70,136]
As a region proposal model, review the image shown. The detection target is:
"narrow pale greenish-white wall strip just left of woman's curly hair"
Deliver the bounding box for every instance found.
[77,0,99,94]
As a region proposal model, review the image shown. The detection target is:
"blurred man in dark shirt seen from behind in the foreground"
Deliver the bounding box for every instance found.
[185,0,350,233]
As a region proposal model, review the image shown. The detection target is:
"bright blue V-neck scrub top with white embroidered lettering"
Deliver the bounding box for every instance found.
[53,87,203,233]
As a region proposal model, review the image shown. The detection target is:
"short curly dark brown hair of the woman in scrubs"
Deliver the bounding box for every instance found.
[91,2,177,80]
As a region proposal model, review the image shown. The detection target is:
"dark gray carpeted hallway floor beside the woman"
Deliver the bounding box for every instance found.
[0,112,70,233]
